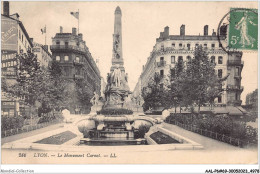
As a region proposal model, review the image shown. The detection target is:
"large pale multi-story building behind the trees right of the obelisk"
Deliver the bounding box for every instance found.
[133,25,243,109]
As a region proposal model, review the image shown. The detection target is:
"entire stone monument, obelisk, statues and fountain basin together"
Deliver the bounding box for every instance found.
[78,7,155,145]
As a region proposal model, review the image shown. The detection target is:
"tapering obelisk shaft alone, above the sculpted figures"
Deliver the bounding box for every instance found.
[110,6,125,72]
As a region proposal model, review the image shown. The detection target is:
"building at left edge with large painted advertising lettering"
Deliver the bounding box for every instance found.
[1,1,33,116]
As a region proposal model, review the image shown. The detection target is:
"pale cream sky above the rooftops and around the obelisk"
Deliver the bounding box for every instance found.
[6,1,258,102]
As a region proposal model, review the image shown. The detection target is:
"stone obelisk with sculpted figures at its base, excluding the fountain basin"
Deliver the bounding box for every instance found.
[104,7,131,108]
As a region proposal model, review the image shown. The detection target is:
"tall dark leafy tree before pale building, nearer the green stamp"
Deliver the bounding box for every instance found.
[183,45,225,113]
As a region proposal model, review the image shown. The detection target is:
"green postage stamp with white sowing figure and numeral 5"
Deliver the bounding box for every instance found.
[228,8,258,50]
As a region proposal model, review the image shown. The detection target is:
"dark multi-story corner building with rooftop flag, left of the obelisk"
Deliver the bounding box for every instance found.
[50,27,101,113]
